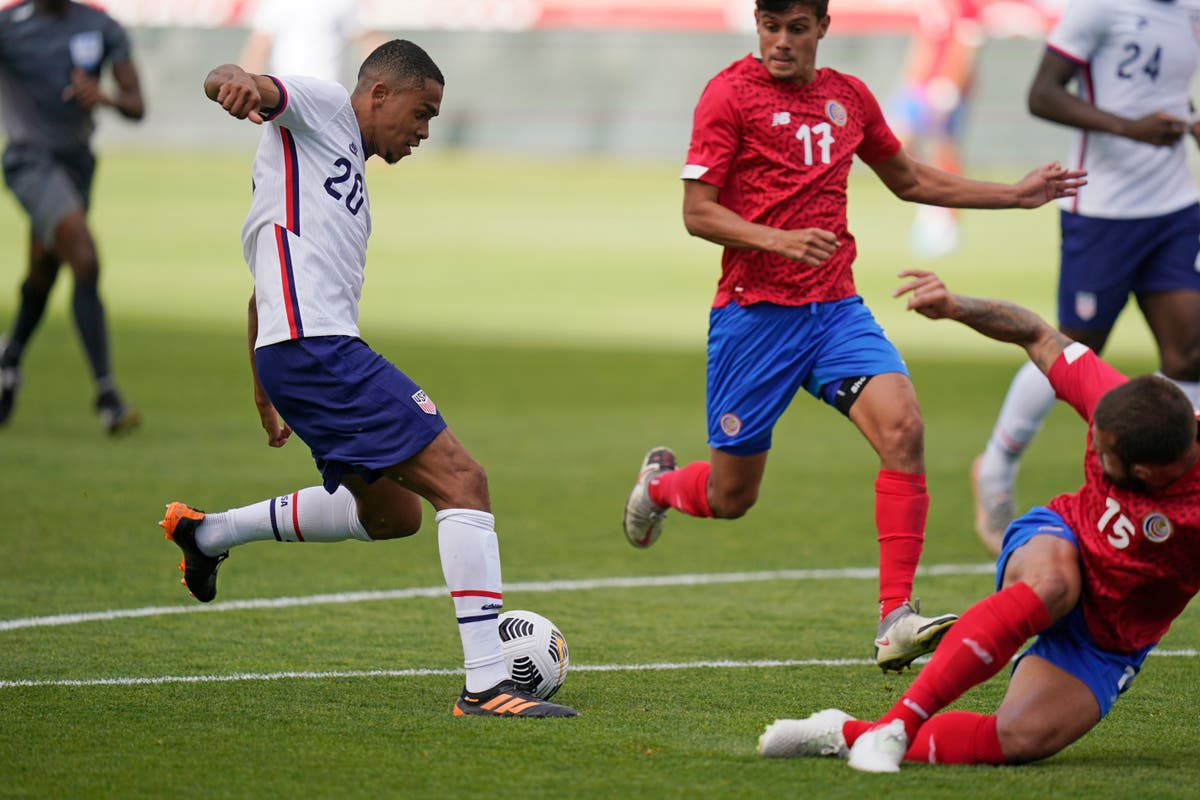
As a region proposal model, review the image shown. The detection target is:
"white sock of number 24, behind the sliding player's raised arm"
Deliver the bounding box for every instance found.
[979,361,1056,491]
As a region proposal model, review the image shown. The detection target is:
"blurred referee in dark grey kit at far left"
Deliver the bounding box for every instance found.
[0,0,145,434]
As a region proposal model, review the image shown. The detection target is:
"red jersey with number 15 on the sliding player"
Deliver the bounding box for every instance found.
[1048,344,1200,652]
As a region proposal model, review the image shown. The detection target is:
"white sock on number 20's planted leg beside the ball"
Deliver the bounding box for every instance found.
[434,509,509,692]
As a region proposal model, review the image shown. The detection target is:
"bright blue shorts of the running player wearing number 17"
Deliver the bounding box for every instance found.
[708,296,908,456]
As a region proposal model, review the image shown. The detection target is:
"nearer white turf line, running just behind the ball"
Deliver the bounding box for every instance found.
[0,649,1200,688]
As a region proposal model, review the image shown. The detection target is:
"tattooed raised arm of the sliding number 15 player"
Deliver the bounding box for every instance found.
[892,270,1072,373]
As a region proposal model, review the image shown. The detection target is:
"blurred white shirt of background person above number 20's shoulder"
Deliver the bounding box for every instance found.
[251,0,367,80]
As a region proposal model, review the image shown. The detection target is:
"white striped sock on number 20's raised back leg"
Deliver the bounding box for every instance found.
[196,486,372,555]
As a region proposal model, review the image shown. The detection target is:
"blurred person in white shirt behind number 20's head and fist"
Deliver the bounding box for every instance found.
[239,0,384,83]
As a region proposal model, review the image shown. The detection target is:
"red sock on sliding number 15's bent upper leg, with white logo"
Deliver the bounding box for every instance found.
[878,583,1050,742]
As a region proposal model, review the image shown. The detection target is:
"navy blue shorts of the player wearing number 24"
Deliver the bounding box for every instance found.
[1058,204,1200,330]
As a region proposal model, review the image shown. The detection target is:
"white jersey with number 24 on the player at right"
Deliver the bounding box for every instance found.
[1046,0,1200,218]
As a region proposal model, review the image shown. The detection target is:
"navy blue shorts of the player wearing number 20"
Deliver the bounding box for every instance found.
[254,336,446,494]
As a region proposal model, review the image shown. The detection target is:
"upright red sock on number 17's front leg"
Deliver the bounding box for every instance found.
[875,469,929,619]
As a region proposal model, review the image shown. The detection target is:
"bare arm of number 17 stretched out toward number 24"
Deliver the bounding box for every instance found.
[870,150,1087,209]
